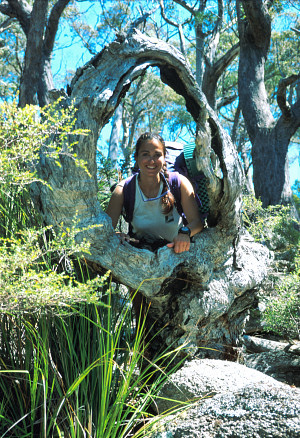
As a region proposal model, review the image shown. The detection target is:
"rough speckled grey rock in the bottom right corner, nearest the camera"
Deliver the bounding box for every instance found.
[149,384,300,438]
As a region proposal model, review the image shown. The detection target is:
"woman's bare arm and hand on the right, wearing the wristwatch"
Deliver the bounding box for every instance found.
[167,175,203,254]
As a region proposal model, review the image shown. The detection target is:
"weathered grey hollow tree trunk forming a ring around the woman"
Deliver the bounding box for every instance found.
[34,30,269,355]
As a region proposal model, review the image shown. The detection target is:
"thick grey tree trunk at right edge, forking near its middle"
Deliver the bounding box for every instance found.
[237,0,300,207]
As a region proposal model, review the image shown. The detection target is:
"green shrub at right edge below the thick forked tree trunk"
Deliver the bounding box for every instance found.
[243,196,300,338]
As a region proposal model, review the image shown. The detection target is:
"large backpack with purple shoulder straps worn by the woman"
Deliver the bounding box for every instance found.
[123,142,209,229]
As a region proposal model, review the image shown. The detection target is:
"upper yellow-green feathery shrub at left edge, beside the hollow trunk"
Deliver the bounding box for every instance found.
[0,101,87,237]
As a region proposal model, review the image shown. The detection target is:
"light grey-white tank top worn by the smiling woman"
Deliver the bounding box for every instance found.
[131,181,182,242]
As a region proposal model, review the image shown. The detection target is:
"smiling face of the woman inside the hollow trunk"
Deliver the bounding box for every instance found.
[135,138,165,176]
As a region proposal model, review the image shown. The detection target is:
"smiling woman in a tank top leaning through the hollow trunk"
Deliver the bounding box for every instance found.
[106,132,203,254]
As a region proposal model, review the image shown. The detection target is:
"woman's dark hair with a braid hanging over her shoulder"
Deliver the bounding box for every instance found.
[134,132,175,215]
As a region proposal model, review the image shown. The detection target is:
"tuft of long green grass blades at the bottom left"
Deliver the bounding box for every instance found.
[0,283,184,438]
